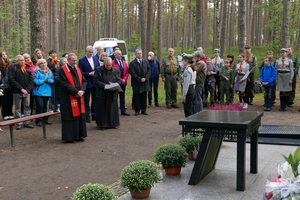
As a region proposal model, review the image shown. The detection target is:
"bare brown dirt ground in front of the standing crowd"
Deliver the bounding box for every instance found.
[0,96,300,200]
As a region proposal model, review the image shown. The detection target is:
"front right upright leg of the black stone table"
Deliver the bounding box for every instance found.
[236,134,246,191]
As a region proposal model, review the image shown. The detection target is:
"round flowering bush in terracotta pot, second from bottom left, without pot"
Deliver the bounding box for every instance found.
[121,160,159,192]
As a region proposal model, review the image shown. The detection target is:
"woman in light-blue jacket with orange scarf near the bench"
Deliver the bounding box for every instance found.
[33,59,54,126]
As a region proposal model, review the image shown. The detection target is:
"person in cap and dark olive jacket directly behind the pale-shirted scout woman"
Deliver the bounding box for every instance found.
[194,51,207,112]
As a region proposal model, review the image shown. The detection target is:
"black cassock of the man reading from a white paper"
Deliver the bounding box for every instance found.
[94,66,121,128]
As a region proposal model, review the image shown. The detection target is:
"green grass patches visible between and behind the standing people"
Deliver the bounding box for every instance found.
[61,46,300,107]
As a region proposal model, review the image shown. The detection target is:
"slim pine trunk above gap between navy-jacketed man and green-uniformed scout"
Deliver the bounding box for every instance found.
[157,0,163,61]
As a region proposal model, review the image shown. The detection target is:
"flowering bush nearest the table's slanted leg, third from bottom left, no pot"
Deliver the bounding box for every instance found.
[153,144,188,169]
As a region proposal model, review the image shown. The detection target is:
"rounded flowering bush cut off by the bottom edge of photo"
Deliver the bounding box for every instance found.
[71,183,117,200]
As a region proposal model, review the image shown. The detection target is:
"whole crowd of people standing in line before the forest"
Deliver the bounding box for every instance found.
[0,45,299,142]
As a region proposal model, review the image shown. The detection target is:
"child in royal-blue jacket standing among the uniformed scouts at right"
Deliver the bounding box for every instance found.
[260,57,276,111]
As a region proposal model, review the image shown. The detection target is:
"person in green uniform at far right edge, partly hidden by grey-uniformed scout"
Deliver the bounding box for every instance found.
[287,46,299,107]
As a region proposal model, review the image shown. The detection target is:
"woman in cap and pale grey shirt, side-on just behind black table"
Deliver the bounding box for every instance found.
[182,54,197,117]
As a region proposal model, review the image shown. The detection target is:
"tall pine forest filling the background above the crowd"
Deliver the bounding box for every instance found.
[0,0,300,60]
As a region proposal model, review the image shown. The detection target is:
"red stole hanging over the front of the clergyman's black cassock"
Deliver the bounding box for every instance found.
[63,65,85,117]
